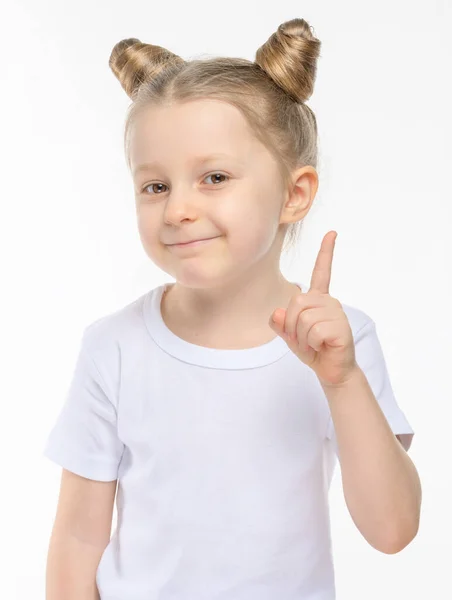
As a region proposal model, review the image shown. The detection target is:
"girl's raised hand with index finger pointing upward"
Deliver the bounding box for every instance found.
[269,231,359,387]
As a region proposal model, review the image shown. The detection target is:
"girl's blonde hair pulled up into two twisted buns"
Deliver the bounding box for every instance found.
[109,19,321,253]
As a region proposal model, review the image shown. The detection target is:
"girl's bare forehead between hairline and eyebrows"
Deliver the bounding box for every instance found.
[130,99,260,167]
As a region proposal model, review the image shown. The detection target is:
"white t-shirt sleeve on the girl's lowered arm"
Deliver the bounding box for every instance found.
[44,330,124,481]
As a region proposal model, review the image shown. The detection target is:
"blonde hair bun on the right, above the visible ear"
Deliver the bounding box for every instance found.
[255,19,321,103]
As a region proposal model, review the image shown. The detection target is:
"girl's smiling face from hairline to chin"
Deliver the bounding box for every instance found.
[130,99,294,288]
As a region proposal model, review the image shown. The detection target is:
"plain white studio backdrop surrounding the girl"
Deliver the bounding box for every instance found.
[0,0,452,600]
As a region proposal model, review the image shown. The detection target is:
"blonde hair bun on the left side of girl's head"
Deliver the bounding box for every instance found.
[108,38,185,100]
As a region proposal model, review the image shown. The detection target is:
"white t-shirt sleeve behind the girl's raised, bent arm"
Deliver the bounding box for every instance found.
[326,319,414,455]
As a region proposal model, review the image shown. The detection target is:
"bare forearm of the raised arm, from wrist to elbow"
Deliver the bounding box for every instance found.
[322,368,421,553]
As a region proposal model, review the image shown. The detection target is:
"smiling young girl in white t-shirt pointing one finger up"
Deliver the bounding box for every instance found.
[45,19,421,600]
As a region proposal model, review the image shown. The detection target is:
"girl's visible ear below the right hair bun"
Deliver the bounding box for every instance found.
[280,166,319,223]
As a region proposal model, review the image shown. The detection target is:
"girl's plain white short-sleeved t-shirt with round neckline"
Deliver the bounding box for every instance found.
[44,283,414,600]
